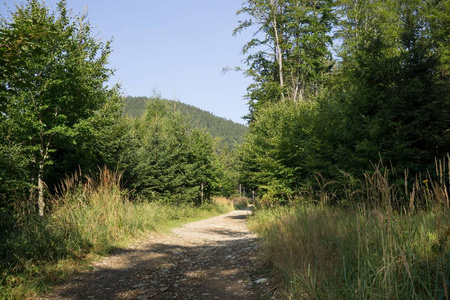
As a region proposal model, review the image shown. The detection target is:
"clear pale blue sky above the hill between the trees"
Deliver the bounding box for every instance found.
[0,0,252,123]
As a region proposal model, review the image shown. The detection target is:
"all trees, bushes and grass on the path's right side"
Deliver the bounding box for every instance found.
[234,0,450,299]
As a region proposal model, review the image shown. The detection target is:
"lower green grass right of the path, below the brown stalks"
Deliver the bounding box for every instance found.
[250,204,450,299]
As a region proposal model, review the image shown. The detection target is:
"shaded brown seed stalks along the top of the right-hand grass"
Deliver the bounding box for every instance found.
[310,155,450,213]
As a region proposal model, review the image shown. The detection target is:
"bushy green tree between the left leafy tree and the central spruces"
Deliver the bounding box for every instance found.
[46,91,138,191]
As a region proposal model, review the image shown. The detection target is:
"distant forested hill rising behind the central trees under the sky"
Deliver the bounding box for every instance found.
[124,96,247,147]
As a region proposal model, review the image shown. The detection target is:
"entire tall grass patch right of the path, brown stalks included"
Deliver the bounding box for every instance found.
[250,162,450,299]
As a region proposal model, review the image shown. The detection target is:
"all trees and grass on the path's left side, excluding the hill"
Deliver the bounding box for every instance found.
[0,0,245,299]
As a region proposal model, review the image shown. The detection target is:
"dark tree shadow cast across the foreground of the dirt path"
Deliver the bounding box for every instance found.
[49,236,270,300]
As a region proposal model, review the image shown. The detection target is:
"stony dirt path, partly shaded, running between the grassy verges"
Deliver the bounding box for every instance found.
[43,210,271,300]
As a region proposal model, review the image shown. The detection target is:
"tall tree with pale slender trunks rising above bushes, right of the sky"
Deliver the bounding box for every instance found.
[233,0,335,120]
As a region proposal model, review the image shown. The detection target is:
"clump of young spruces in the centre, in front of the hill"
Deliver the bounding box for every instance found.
[132,100,218,204]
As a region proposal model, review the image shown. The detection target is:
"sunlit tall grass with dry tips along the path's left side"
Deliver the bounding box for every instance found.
[0,168,227,299]
